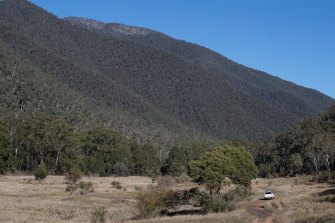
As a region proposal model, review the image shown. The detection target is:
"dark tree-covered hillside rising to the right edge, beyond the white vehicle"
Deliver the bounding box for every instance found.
[255,105,335,179]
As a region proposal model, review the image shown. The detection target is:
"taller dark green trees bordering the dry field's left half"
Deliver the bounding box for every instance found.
[0,114,161,176]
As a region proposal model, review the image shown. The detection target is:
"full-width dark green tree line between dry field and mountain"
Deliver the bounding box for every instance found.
[0,105,335,180]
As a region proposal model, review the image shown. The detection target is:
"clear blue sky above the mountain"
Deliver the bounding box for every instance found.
[30,0,335,98]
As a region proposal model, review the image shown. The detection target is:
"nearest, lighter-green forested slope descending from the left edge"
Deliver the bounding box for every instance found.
[0,41,209,145]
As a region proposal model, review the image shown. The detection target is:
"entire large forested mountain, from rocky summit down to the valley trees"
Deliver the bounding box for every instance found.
[0,0,334,145]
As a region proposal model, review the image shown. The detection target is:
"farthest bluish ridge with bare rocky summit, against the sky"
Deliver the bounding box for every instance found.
[65,17,334,116]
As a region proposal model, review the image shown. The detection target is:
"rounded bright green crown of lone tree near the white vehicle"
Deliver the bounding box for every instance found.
[188,145,257,194]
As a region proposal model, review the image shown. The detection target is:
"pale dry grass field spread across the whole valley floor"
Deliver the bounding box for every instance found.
[0,176,335,223]
